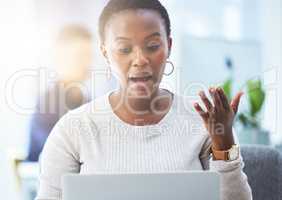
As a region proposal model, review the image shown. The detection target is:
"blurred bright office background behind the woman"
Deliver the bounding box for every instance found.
[0,0,282,200]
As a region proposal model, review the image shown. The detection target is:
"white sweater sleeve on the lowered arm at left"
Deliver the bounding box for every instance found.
[36,113,80,200]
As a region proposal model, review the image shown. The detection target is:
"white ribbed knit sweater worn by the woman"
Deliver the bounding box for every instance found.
[37,92,252,200]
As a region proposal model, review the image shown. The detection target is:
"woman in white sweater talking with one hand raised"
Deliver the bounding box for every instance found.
[37,0,252,200]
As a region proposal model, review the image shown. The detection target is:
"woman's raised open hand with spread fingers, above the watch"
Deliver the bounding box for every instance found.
[194,87,243,150]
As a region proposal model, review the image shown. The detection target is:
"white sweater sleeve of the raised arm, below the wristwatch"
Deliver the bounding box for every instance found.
[200,129,252,200]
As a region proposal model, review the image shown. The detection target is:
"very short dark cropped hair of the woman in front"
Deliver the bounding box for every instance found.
[99,0,171,42]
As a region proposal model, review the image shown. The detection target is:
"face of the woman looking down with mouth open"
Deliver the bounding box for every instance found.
[101,9,171,97]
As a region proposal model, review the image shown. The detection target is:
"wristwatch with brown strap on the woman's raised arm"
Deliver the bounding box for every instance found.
[211,144,240,161]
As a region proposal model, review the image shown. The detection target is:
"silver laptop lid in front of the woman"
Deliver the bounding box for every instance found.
[62,171,219,200]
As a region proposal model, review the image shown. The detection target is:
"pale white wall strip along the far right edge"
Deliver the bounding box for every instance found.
[259,0,282,143]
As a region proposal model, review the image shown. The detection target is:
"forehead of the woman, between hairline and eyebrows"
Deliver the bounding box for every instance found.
[105,9,166,39]
